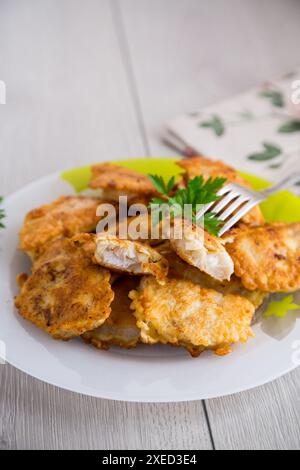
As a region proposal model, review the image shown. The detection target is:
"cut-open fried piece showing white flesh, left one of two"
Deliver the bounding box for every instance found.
[74,233,168,282]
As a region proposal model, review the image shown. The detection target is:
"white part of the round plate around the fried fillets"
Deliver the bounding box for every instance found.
[0,160,300,402]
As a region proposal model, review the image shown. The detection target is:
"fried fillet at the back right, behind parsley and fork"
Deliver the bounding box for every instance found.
[177,156,264,225]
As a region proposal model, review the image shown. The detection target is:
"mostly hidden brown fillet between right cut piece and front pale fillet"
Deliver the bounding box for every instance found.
[156,241,268,309]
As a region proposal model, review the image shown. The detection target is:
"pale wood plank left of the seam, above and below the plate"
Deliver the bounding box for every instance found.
[0,0,211,449]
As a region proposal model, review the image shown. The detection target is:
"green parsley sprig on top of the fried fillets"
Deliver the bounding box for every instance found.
[148,175,226,236]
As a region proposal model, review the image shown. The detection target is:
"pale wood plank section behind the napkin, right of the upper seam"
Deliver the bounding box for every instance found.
[118,0,300,156]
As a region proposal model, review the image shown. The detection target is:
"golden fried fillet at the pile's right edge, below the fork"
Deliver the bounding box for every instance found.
[226,222,300,292]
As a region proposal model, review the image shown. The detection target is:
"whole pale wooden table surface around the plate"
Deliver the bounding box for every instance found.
[0,0,300,449]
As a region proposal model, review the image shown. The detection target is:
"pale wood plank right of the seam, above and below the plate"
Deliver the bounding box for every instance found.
[119,0,300,449]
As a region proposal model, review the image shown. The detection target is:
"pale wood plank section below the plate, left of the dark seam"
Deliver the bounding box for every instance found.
[0,365,211,450]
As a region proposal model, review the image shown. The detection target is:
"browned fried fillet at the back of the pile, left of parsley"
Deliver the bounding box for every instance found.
[89,163,156,199]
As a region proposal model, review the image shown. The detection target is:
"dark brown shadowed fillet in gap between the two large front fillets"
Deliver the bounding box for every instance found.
[82,276,140,349]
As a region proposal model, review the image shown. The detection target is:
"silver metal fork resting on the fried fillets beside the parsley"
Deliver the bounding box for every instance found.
[196,172,300,237]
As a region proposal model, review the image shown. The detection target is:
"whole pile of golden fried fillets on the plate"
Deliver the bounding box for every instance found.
[15,156,300,357]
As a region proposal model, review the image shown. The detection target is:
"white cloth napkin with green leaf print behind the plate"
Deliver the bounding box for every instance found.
[164,68,300,185]
